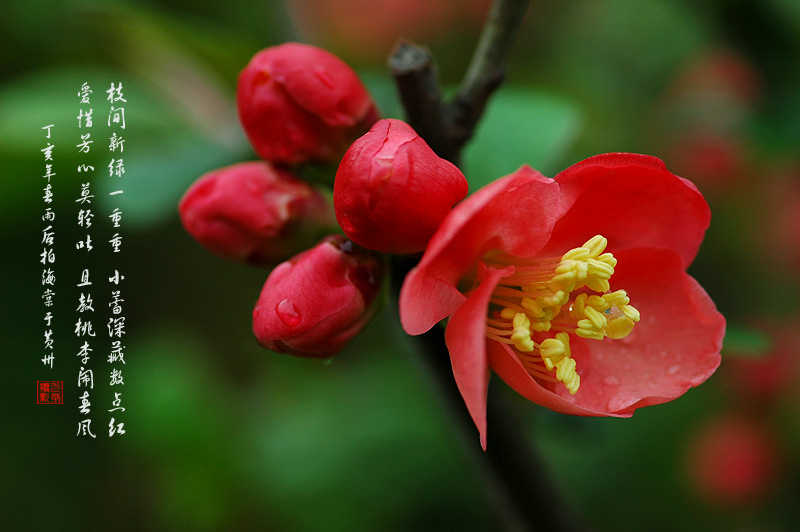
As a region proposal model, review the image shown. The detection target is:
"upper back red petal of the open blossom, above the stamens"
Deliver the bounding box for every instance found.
[547,153,711,269]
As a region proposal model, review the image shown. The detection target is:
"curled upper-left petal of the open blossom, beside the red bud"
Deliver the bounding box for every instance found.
[400,166,559,334]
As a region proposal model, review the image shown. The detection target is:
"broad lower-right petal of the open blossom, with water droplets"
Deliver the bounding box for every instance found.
[576,248,725,413]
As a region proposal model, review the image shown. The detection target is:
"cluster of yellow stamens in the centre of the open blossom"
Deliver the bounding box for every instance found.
[484,235,639,395]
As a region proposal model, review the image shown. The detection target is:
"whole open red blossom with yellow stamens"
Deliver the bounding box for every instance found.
[400,154,725,448]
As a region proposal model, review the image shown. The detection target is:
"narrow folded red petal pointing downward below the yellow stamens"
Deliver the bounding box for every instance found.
[444,266,514,450]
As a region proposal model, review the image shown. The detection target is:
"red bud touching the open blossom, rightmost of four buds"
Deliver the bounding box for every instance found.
[333,119,467,253]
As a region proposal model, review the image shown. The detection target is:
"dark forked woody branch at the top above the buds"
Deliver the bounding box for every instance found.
[389,0,528,165]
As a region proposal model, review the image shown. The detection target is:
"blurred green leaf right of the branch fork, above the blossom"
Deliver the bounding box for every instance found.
[463,88,582,191]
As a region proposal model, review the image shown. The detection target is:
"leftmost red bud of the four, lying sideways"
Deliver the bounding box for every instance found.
[178,161,333,266]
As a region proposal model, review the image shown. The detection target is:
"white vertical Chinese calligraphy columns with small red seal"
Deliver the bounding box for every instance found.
[36,81,134,439]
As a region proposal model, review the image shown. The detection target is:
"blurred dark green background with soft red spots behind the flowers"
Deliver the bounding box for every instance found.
[0,0,800,532]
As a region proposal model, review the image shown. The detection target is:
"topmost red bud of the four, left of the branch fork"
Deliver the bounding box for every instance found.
[236,43,378,164]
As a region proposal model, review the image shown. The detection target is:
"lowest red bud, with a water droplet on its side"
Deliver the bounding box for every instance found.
[253,235,384,358]
